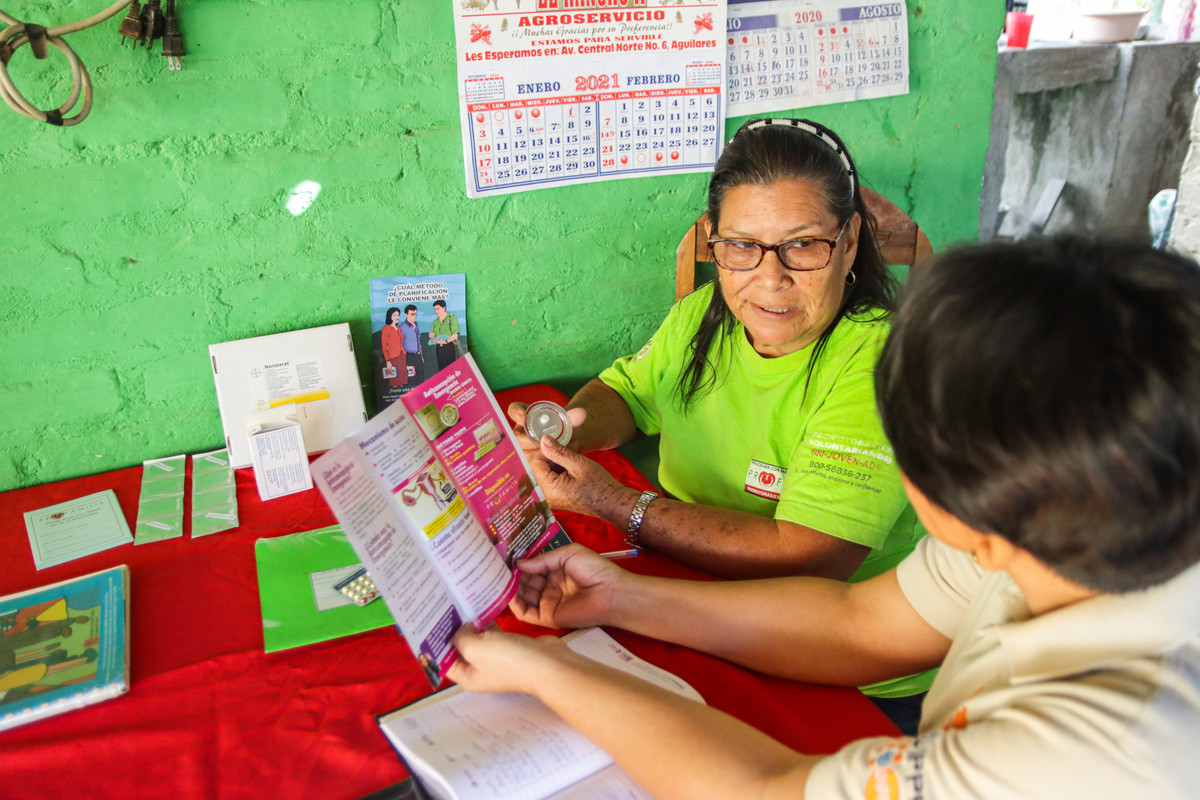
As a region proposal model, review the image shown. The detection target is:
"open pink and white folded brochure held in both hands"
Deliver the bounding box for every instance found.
[312,354,560,686]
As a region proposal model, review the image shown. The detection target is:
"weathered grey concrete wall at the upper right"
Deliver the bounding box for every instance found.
[979,42,1200,240]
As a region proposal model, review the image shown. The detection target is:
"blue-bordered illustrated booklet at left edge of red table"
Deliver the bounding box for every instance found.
[0,566,130,730]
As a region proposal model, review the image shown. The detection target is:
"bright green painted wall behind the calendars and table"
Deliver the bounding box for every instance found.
[0,0,1002,488]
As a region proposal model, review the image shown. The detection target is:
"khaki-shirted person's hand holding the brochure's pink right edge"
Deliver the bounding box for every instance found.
[509,545,631,627]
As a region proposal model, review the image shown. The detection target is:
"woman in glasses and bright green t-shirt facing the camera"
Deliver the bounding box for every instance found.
[509,119,932,730]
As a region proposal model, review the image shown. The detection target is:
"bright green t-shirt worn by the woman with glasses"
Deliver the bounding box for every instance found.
[600,284,932,697]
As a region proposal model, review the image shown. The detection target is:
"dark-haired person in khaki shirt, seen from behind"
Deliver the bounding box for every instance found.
[450,239,1200,800]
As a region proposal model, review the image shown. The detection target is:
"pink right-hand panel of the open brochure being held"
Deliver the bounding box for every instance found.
[401,353,559,578]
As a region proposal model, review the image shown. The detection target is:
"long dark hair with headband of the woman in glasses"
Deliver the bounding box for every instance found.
[679,120,896,409]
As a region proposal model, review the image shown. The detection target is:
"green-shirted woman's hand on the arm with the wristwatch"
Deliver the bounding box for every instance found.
[526,437,637,517]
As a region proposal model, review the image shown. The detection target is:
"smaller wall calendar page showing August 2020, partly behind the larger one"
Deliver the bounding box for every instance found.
[726,0,908,116]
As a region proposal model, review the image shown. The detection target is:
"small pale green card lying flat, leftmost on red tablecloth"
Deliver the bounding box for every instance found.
[25,489,133,570]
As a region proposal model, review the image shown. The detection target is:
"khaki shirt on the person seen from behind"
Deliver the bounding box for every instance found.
[806,537,1200,800]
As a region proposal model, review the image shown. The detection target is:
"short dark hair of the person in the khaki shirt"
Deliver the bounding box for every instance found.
[875,237,1200,591]
